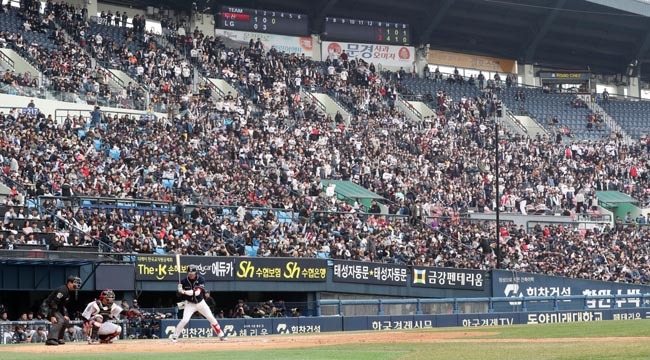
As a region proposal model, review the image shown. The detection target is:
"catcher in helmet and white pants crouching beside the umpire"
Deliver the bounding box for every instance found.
[81,289,122,344]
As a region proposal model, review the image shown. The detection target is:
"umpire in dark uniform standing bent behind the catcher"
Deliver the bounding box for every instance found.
[41,275,81,345]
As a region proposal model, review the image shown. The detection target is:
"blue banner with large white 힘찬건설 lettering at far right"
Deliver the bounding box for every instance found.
[492,270,650,311]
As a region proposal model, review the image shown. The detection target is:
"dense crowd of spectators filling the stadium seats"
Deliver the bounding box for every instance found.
[0,0,650,283]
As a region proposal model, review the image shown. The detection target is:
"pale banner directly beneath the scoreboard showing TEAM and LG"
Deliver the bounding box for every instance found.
[214,29,314,57]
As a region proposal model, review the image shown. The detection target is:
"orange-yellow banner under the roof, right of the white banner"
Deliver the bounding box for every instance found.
[427,50,517,74]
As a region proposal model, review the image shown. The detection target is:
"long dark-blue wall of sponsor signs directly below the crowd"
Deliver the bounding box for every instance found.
[0,251,650,315]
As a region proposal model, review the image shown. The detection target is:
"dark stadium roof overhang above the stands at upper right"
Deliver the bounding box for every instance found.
[114,0,650,79]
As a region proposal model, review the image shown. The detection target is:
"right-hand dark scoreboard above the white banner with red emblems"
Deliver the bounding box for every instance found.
[321,17,411,45]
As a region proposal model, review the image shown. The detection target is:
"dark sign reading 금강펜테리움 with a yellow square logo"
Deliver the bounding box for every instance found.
[411,266,485,290]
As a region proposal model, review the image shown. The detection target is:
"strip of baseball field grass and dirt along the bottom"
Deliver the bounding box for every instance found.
[0,320,650,360]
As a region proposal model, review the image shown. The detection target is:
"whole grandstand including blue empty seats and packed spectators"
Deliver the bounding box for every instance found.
[0,0,650,292]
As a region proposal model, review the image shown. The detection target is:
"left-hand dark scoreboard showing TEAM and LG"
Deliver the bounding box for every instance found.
[217,6,309,36]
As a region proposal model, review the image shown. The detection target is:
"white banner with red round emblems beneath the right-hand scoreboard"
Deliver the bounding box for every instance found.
[321,41,415,72]
